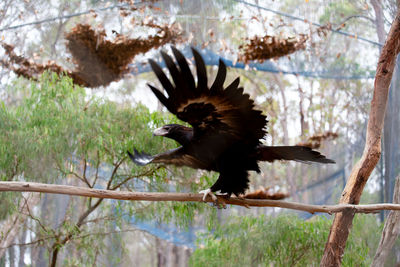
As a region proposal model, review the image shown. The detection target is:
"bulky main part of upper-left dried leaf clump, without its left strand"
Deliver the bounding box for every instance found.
[65,23,182,87]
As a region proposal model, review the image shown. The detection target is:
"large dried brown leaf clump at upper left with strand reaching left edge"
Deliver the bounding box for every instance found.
[1,22,183,87]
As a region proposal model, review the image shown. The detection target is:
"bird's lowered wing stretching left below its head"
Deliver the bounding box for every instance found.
[127,147,211,169]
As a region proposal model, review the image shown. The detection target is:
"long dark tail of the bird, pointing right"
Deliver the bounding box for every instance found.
[258,145,335,163]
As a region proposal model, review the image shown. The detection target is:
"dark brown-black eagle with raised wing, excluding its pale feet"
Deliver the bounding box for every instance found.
[128,47,334,195]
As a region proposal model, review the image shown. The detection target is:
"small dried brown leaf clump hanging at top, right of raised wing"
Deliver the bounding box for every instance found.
[238,34,308,63]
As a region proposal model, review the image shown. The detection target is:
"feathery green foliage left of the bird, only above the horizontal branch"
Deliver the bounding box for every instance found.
[0,73,182,186]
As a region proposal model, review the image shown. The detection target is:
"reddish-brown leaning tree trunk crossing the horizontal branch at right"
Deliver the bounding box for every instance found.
[320,7,400,266]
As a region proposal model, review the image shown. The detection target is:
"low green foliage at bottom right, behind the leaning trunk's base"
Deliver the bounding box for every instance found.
[190,215,380,266]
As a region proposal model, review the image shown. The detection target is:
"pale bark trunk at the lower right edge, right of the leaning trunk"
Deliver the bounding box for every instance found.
[371,176,400,267]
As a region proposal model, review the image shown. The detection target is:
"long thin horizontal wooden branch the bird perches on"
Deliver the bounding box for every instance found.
[0,182,400,214]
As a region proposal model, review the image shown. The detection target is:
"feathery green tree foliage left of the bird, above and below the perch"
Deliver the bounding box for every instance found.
[0,73,215,265]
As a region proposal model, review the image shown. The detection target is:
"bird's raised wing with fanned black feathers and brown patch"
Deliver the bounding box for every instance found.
[149,47,267,153]
